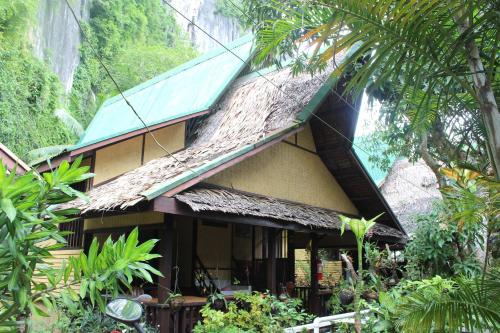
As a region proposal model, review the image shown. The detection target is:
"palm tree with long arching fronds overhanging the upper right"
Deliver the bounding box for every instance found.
[247,0,500,178]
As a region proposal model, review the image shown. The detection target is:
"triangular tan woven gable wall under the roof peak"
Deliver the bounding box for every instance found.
[207,125,358,214]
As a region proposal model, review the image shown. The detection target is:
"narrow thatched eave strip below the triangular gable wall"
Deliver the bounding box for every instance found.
[175,184,406,239]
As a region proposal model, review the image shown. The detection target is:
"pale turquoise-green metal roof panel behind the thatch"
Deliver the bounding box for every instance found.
[72,35,253,150]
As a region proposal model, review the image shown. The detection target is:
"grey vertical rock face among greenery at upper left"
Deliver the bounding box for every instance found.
[32,0,91,92]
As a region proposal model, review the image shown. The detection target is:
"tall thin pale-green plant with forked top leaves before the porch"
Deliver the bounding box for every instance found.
[340,214,382,333]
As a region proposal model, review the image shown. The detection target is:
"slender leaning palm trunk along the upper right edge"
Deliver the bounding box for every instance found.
[457,13,500,179]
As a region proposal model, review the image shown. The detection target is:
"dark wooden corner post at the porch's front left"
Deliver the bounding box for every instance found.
[158,214,174,333]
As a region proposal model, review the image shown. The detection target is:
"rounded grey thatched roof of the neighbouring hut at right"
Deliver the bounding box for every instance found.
[380,159,442,234]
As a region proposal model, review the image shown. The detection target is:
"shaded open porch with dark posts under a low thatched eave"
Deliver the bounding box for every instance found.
[79,187,406,333]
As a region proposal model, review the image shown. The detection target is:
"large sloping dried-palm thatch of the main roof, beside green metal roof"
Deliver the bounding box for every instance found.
[70,54,343,212]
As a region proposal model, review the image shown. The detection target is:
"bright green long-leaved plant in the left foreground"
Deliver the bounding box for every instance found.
[0,157,160,330]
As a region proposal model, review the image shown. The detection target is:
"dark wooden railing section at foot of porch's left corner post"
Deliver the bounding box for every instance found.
[144,303,205,333]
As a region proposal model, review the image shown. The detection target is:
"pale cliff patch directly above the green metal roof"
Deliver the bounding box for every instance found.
[168,0,241,53]
